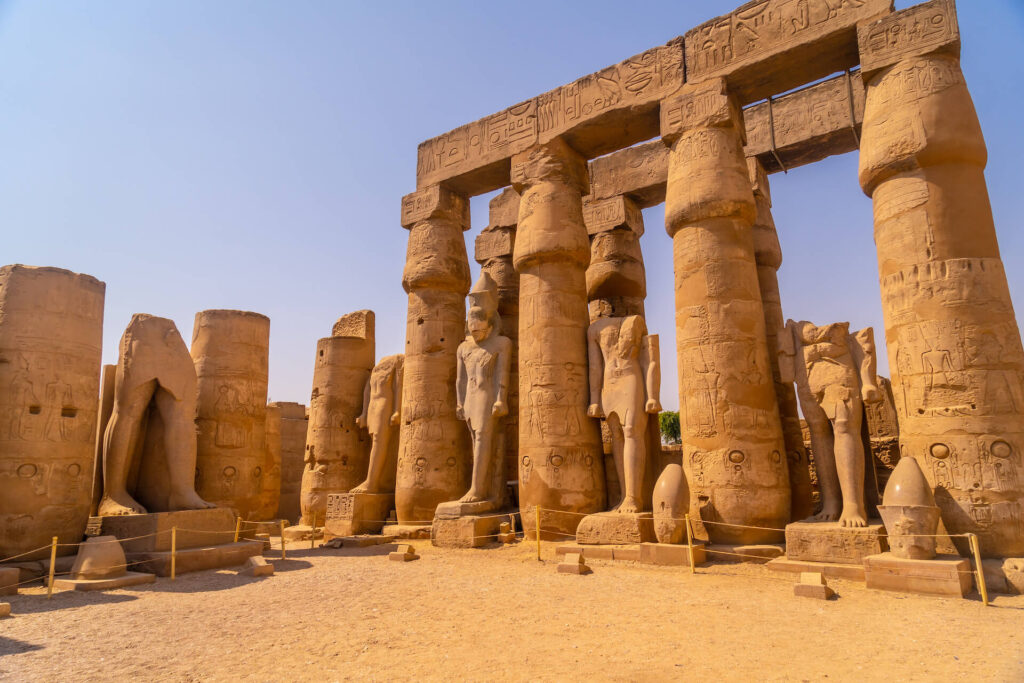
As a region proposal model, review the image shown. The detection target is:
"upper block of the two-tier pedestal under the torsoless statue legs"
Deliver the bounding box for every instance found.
[88,508,236,553]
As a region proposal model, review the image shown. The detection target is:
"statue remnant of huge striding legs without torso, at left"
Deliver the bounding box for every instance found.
[98,313,214,516]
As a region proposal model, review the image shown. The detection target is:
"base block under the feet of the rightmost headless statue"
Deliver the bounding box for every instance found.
[785,522,889,564]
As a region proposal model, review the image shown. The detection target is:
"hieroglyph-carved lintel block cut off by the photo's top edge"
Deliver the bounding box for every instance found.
[684,0,893,104]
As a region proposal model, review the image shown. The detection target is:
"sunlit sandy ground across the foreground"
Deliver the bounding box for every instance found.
[0,541,1024,682]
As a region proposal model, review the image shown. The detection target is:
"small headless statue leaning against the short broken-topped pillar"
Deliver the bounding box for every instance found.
[350,353,406,494]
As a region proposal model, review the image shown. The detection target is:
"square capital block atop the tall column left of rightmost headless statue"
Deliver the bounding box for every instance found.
[662,78,743,144]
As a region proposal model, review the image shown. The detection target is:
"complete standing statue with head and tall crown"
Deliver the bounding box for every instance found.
[456,272,512,505]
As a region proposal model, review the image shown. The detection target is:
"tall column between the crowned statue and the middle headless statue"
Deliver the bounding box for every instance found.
[512,138,605,541]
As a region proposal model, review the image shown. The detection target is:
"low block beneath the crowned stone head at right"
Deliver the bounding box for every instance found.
[864,553,974,598]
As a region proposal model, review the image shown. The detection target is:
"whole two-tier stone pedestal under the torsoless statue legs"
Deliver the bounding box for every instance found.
[89,508,263,577]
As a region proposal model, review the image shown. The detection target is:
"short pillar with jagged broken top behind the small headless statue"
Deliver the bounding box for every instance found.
[299,310,376,539]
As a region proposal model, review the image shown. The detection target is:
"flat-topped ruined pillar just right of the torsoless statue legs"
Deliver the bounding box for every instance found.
[191,310,270,519]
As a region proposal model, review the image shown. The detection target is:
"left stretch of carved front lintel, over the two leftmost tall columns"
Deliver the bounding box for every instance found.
[416,38,684,196]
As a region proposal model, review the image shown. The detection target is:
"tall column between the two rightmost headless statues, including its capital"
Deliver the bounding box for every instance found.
[662,79,790,543]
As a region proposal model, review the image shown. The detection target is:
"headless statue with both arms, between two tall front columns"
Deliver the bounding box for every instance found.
[587,315,662,514]
